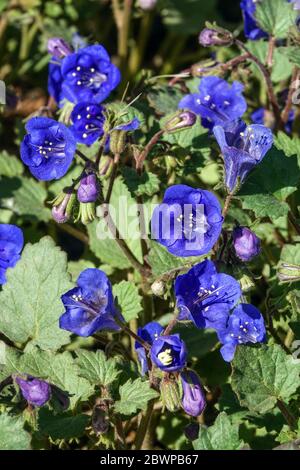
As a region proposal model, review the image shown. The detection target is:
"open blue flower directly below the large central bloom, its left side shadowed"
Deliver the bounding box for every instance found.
[175,260,241,329]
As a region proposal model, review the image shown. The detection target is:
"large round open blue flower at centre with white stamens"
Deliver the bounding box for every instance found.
[151,184,223,256]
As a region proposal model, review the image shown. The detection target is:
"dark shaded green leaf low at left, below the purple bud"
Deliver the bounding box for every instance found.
[38,408,90,440]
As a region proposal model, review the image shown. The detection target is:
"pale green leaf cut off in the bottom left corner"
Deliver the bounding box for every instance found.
[0,413,30,450]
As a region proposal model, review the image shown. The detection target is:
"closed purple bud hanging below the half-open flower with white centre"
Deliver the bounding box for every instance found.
[180,370,206,416]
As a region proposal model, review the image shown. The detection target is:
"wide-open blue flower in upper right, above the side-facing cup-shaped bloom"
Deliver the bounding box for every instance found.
[179,76,247,129]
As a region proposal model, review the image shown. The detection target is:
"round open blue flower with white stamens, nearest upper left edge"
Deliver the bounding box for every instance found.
[21,117,76,181]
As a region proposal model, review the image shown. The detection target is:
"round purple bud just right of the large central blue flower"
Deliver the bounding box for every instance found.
[232,227,261,261]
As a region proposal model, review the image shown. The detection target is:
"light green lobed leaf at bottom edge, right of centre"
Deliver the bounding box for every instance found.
[193,412,244,450]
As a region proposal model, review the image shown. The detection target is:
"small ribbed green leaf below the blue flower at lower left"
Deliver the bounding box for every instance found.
[76,349,121,387]
